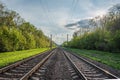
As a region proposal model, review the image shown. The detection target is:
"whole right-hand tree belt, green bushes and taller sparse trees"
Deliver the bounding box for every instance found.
[63,4,120,52]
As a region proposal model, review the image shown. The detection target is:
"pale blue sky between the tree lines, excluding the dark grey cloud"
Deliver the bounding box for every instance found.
[0,0,120,44]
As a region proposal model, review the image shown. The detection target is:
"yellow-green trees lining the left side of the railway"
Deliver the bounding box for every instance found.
[0,2,50,52]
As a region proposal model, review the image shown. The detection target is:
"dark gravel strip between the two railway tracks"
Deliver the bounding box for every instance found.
[25,48,82,80]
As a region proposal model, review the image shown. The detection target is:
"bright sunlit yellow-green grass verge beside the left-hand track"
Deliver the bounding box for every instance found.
[0,48,48,68]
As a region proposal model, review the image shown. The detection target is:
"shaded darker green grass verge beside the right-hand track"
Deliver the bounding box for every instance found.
[65,48,120,70]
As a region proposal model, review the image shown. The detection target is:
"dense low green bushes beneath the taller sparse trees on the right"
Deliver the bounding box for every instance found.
[67,28,120,52]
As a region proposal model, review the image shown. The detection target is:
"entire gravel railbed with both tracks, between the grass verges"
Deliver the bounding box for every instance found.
[0,48,118,80]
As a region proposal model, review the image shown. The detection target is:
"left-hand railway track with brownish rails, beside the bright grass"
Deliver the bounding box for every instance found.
[0,50,54,80]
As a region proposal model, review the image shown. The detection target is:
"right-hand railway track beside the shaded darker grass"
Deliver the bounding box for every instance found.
[64,51,118,80]
